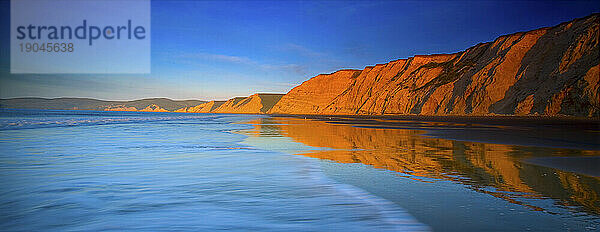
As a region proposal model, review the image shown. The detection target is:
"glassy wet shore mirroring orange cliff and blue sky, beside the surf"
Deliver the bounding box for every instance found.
[239,117,600,231]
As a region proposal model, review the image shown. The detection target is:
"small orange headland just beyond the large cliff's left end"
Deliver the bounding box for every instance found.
[210,93,283,114]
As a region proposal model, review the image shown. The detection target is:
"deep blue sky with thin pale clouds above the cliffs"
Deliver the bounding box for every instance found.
[0,1,600,100]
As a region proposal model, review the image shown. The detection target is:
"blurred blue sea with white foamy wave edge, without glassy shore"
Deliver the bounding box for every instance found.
[0,111,428,231]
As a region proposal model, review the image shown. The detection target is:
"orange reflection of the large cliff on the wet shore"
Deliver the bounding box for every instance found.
[243,117,600,214]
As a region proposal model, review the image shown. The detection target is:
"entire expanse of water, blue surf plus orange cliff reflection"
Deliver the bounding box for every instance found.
[0,110,600,231]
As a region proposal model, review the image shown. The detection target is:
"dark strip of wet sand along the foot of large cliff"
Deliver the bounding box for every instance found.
[273,115,600,150]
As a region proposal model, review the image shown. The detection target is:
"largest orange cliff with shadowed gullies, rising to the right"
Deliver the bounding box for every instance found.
[269,14,600,117]
